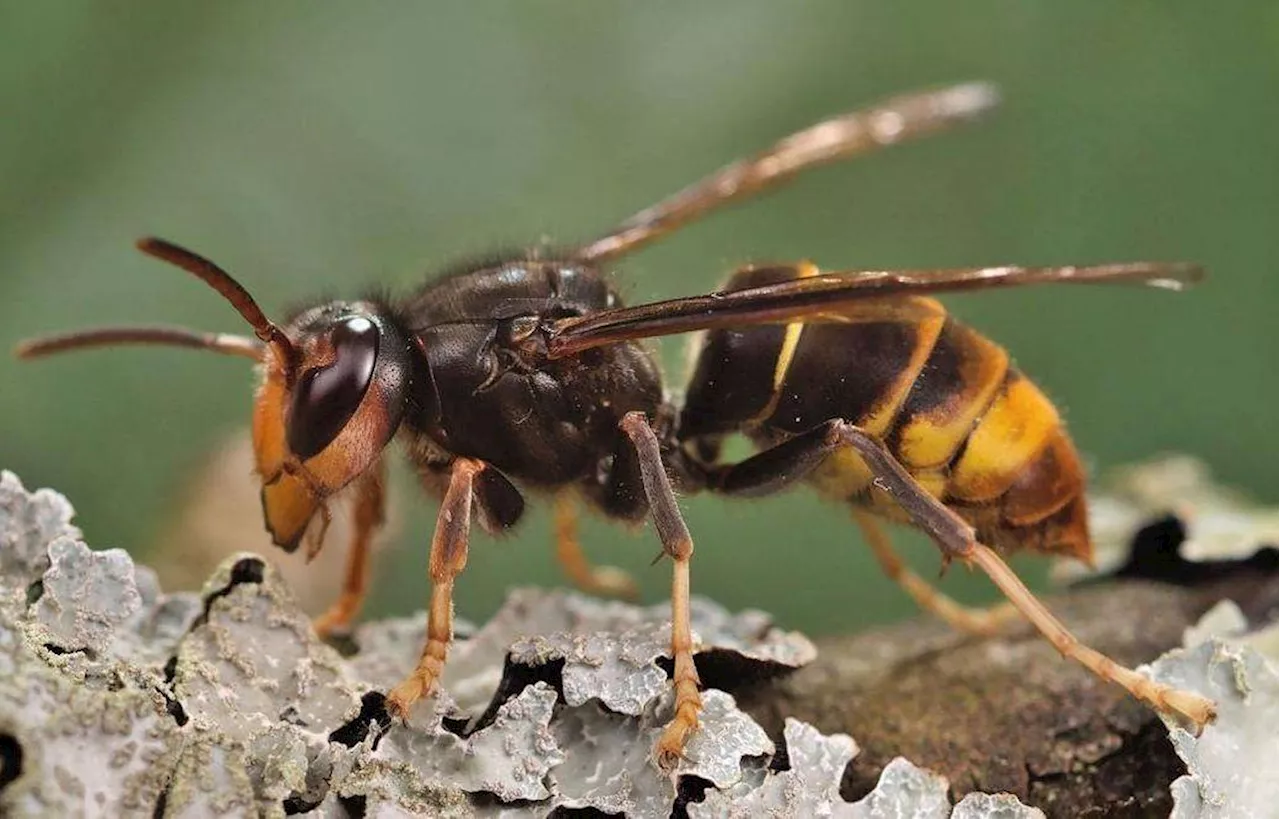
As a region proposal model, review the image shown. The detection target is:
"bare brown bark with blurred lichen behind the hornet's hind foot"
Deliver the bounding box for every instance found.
[739,575,1280,816]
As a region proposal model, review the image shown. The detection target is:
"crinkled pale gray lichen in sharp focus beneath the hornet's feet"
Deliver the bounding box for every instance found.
[0,472,1280,819]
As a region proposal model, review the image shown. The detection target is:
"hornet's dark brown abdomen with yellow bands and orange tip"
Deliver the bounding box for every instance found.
[681,267,1092,561]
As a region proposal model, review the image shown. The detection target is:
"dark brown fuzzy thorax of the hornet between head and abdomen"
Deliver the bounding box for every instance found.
[392,260,663,523]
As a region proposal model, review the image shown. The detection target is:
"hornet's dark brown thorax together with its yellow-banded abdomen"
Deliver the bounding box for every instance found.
[376,260,1091,561]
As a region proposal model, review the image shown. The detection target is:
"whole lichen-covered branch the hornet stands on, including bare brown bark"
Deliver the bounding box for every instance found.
[0,473,1280,819]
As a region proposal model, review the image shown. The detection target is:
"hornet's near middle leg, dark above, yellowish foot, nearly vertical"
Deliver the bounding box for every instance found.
[621,412,703,770]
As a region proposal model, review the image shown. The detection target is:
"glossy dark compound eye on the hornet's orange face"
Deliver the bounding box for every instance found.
[287,316,379,461]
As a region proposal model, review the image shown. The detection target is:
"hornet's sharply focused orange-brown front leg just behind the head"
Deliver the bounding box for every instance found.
[387,458,485,718]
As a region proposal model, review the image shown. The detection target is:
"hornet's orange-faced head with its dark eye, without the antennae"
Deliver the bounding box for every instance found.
[253,306,407,552]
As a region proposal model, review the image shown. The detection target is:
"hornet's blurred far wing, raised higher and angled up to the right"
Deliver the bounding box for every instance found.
[577,83,1000,262]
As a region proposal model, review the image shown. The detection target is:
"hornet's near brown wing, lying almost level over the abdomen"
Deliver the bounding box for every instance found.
[548,262,1203,357]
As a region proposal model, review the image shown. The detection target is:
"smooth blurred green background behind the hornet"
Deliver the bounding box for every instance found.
[0,0,1280,632]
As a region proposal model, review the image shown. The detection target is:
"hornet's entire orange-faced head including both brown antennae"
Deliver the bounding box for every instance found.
[11,238,412,552]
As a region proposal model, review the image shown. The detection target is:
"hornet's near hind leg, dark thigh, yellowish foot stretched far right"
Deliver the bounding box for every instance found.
[712,420,1215,733]
